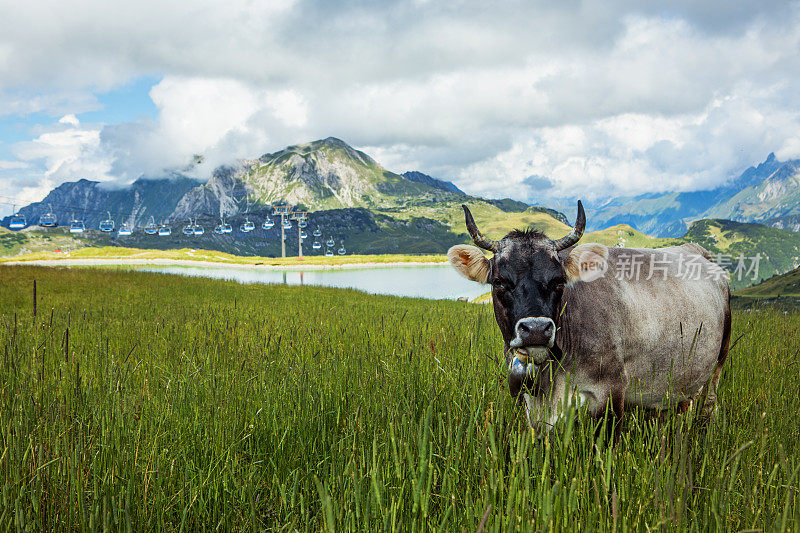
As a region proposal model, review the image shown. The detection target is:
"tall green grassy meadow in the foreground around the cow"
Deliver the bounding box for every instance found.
[0,266,800,531]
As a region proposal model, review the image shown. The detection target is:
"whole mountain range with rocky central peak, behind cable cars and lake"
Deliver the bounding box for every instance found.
[0,137,500,255]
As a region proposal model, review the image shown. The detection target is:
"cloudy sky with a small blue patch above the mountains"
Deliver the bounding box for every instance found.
[0,0,800,213]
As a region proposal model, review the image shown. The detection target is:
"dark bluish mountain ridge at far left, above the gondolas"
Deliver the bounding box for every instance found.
[3,173,199,227]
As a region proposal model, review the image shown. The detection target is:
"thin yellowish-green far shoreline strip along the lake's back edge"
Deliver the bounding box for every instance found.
[0,258,448,270]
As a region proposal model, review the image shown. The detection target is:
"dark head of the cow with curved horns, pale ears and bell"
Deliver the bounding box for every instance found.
[447,201,607,396]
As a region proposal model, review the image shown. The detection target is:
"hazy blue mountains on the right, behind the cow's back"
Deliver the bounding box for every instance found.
[587,153,800,236]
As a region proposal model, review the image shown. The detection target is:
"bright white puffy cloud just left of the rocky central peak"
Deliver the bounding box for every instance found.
[101,76,308,181]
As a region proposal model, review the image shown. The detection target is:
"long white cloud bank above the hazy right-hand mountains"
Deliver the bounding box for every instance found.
[459,82,800,201]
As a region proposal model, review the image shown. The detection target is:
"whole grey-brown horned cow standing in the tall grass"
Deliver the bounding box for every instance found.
[447,201,731,437]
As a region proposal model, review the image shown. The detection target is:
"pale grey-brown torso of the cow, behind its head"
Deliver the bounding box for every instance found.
[556,245,730,407]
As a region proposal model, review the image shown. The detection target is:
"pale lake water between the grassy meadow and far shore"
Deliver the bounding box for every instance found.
[137,265,490,300]
